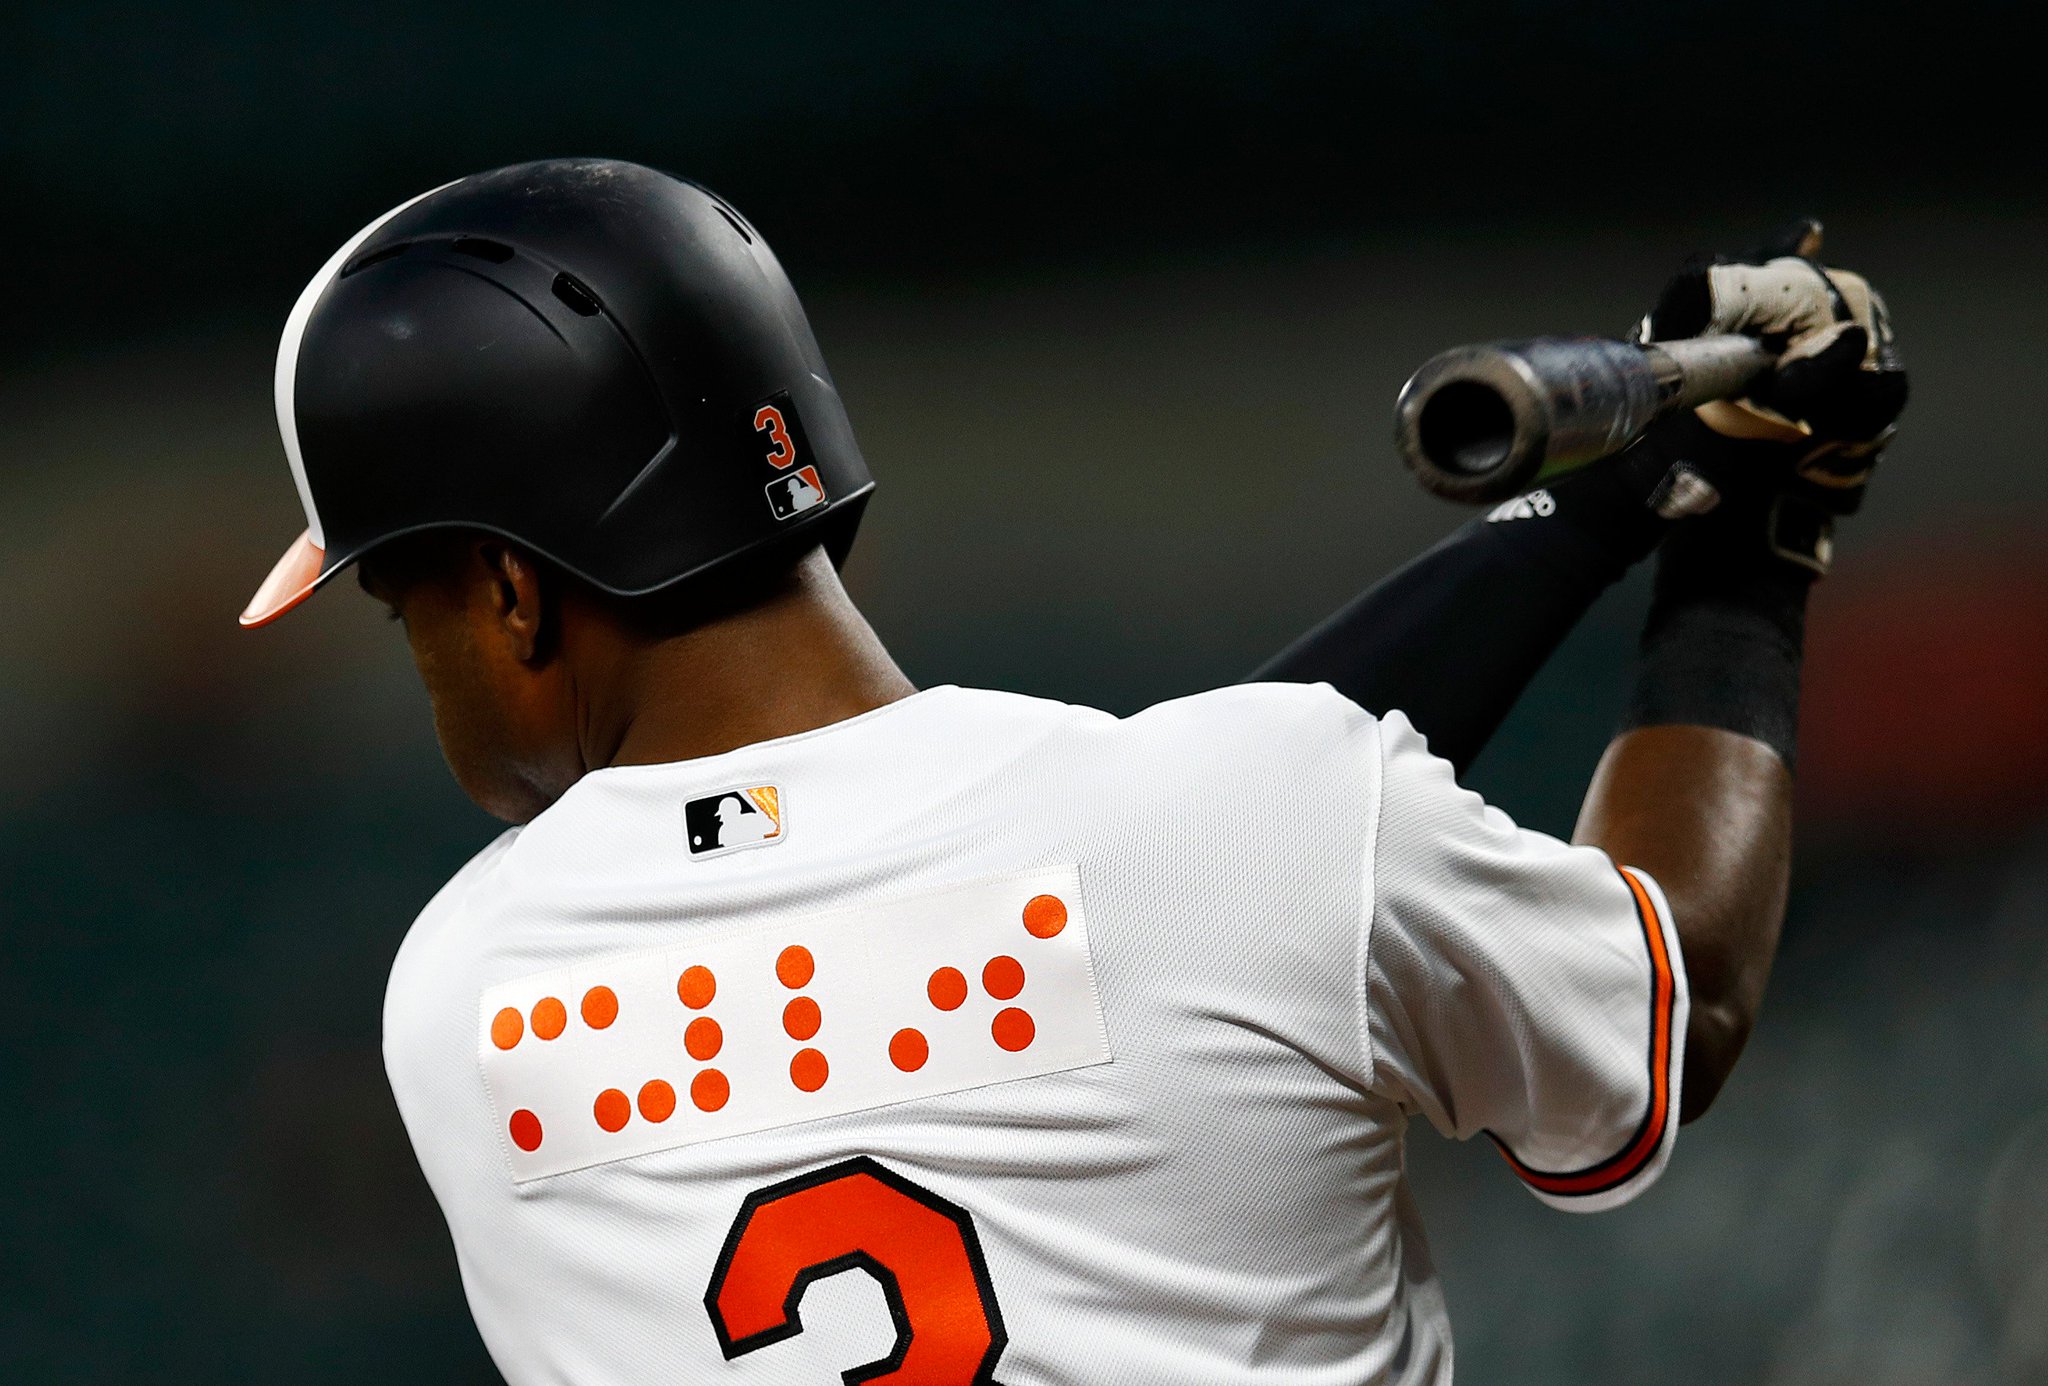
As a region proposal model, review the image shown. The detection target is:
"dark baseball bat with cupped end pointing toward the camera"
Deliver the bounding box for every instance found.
[1395,336,1774,504]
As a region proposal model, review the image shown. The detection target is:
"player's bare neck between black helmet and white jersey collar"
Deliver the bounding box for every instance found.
[580,553,915,770]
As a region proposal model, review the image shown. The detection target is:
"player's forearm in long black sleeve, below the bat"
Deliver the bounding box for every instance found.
[1251,440,1669,776]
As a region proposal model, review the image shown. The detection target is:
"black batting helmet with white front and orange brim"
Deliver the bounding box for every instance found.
[242,160,874,626]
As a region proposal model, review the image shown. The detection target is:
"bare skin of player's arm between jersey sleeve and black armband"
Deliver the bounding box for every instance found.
[1573,725,1792,1122]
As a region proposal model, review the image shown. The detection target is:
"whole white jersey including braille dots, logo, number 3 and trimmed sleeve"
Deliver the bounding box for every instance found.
[385,686,1686,1386]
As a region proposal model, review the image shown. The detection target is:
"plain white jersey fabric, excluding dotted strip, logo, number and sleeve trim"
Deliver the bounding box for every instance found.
[385,686,1681,1386]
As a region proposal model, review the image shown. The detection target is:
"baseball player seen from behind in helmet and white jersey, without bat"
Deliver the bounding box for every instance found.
[242,160,1903,1386]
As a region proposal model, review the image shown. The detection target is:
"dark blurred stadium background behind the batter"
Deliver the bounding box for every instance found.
[0,0,2048,1386]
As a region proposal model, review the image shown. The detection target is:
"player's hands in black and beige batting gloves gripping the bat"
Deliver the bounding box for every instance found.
[1636,221,1907,571]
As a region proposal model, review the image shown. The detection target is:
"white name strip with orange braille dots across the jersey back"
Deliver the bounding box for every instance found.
[477,866,1110,1183]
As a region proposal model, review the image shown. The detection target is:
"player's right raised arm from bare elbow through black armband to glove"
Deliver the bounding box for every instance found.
[1575,235,1905,1120]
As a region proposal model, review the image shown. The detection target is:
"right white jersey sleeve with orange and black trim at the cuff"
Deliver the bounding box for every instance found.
[1362,712,1688,1212]
